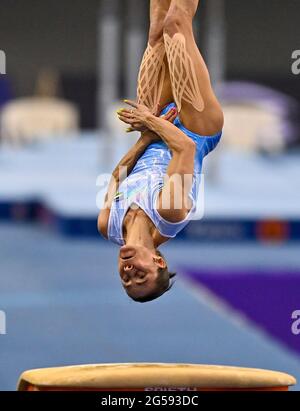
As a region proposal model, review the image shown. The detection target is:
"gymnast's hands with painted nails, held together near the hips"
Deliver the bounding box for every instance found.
[117,100,178,133]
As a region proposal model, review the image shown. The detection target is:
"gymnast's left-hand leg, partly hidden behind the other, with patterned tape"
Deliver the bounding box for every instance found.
[137,0,174,111]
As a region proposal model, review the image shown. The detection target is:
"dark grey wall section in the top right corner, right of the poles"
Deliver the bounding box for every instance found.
[226,0,300,77]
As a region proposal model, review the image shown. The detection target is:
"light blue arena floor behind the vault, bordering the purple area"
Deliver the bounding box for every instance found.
[0,224,300,390]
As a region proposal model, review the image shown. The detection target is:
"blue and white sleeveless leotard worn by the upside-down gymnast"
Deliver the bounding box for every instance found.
[108,103,222,245]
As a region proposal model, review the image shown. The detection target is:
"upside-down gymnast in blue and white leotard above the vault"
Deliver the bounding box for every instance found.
[98,0,223,302]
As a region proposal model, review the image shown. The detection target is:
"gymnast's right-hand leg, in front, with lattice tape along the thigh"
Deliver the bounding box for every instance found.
[164,0,223,135]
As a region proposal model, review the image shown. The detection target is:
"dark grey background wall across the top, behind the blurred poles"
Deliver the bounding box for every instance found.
[0,0,300,126]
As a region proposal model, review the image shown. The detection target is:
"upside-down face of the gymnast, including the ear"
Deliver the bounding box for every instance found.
[119,245,166,299]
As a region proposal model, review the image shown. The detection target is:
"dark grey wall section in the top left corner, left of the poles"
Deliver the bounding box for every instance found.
[0,0,99,94]
